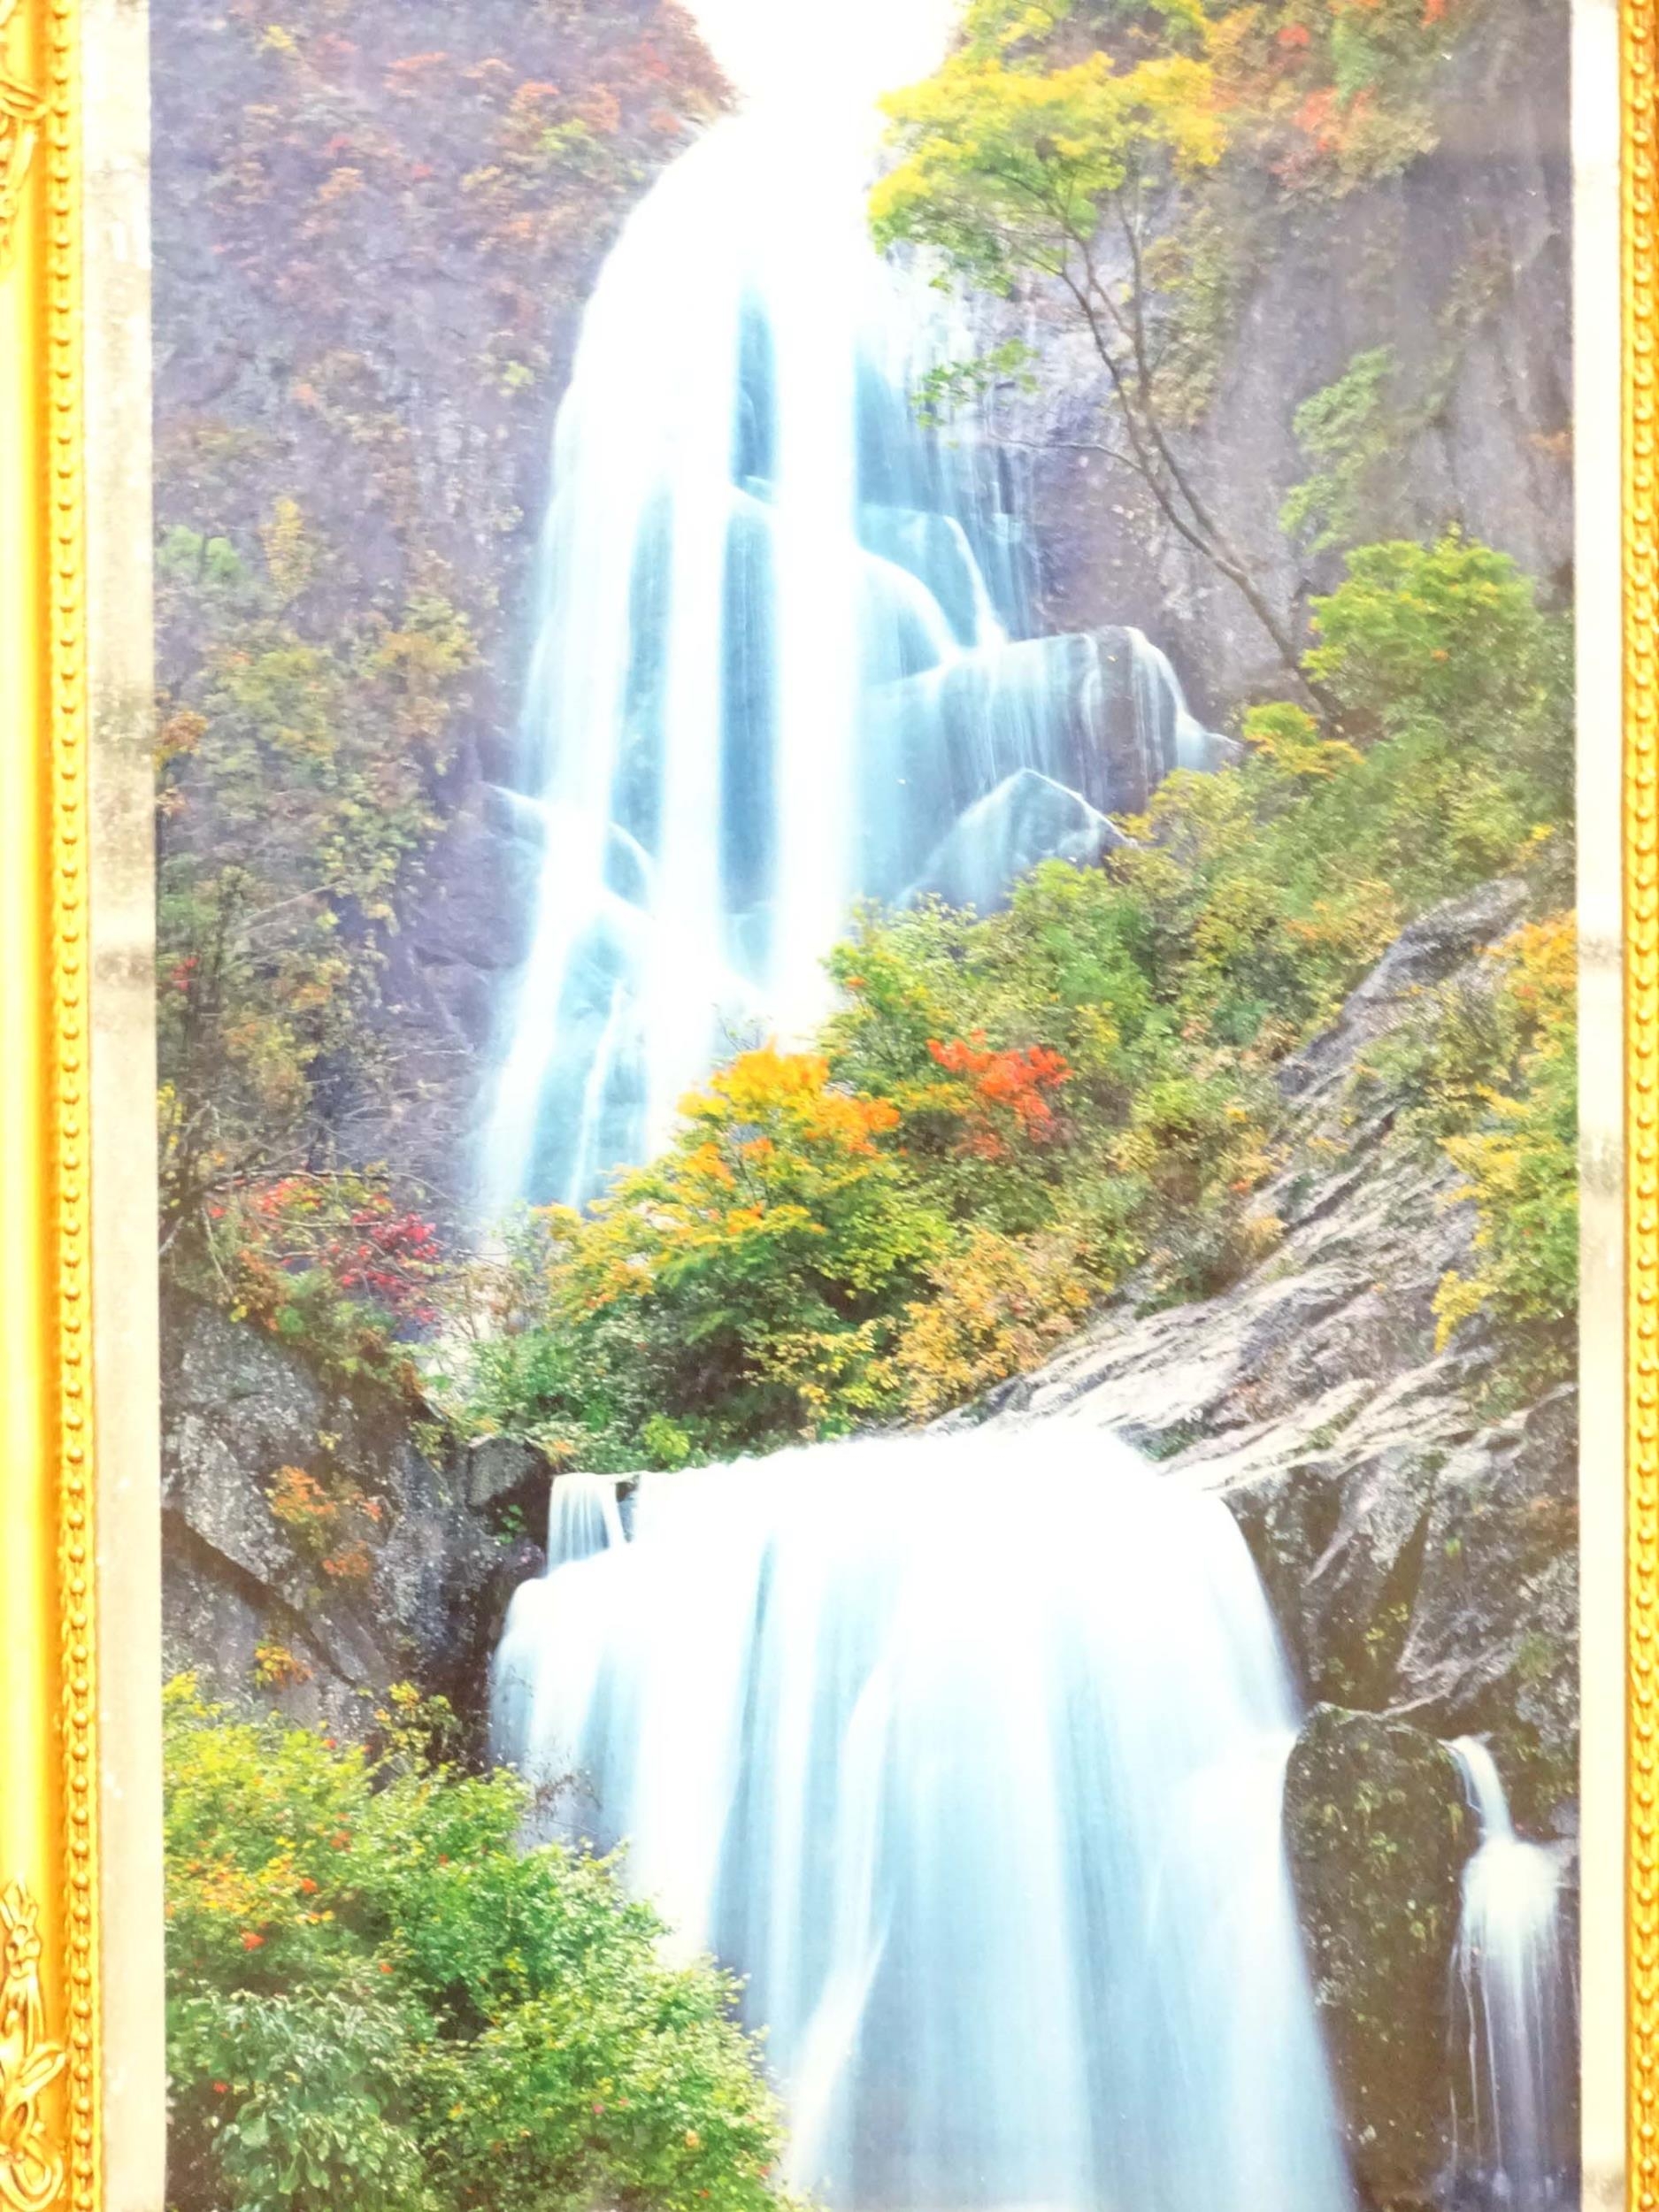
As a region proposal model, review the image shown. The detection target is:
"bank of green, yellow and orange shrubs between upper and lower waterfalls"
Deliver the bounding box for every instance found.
[445,534,1571,1469]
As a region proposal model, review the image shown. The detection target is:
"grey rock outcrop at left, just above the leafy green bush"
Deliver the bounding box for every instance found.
[162,1303,547,1734]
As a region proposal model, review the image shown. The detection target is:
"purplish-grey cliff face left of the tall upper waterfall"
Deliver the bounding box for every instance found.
[150,0,728,1217]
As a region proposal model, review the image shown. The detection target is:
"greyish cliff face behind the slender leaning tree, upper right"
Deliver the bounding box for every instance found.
[973,0,1573,719]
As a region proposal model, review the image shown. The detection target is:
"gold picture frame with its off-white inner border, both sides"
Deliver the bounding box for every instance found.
[0,0,1659,2212]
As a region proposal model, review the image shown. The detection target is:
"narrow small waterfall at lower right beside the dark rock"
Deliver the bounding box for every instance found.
[1451,1737,1578,2212]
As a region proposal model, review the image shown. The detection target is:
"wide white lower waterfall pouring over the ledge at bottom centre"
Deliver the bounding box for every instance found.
[494,1425,1349,2212]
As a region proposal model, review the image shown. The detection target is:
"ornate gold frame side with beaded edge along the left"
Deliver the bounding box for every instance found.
[0,0,102,2212]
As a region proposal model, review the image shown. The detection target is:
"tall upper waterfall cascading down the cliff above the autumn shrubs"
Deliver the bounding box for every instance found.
[482,56,1219,1206]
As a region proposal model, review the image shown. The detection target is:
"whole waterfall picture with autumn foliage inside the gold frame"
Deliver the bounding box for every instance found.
[150,0,1593,2212]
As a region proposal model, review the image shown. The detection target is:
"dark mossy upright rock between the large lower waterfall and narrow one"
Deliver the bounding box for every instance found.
[1286,1706,1476,2212]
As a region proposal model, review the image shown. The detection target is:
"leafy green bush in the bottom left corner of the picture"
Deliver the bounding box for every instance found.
[166,1679,781,2212]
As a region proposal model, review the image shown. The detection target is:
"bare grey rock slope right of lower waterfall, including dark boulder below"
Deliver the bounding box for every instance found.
[982,883,1578,2208]
